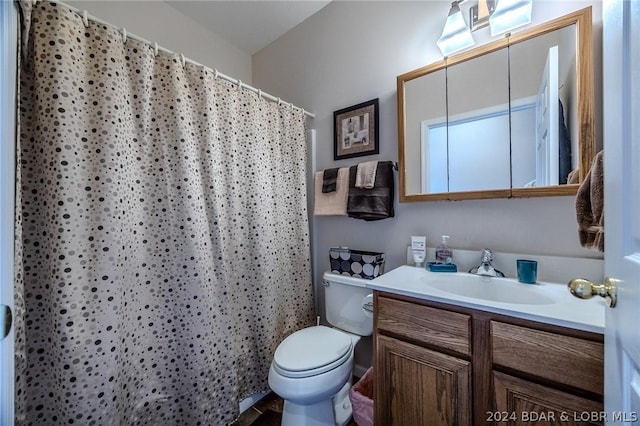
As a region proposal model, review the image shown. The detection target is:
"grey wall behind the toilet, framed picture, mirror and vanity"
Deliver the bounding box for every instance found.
[253,0,602,370]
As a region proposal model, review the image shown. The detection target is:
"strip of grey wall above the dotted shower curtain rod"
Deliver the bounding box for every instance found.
[64,1,252,84]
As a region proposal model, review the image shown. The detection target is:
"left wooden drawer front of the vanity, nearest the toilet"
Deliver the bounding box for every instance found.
[376,296,471,355]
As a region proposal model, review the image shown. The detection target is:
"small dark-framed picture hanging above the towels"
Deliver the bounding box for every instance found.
[333,98,380,160]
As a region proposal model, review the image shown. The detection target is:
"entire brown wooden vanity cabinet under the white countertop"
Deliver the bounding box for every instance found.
[374,291,604,426]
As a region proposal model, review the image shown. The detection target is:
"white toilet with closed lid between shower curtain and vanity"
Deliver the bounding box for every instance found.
[269,272,373,426]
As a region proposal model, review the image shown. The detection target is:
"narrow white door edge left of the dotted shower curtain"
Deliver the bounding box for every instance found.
[0,1,18,426]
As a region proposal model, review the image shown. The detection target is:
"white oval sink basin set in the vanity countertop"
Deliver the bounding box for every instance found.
[421,272,555,305]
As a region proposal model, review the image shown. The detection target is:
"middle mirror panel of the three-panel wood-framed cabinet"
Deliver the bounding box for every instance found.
[443,49,511,195]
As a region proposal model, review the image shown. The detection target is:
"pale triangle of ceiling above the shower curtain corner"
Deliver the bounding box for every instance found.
[166,0,331,55]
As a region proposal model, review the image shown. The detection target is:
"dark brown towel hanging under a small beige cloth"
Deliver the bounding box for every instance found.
[347,161,395,220]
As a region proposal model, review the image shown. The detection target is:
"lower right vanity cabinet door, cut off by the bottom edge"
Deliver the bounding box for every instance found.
[487,371,606,426]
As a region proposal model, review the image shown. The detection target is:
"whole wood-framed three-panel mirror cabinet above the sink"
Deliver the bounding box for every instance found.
[397,8,595,202]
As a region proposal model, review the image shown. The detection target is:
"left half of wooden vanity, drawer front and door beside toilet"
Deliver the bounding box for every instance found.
[374,295,472,426]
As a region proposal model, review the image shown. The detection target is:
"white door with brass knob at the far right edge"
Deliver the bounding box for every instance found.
[602,0,640,424]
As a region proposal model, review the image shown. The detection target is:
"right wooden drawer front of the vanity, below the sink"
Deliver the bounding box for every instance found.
[491,321,604,395]
